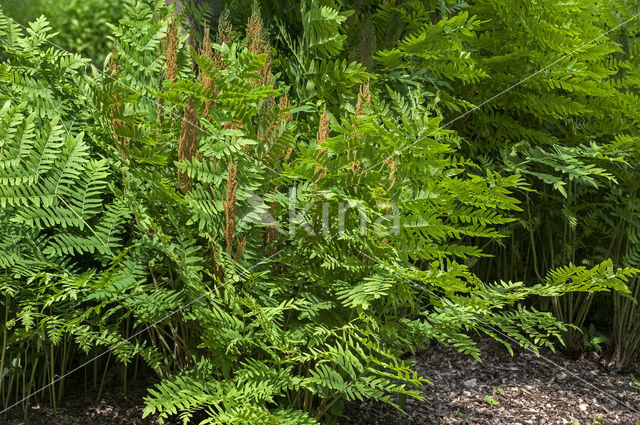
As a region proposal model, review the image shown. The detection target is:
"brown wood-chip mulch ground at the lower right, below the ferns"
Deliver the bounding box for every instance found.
[340,341,640,425]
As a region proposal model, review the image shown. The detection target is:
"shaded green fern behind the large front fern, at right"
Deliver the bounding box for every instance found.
[332,0,640,364]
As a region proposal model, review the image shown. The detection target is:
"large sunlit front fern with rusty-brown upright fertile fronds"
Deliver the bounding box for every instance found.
[0,1,636,424]
